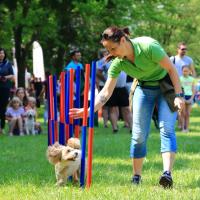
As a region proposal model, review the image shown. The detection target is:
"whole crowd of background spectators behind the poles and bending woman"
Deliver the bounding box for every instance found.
[0,42,200,136]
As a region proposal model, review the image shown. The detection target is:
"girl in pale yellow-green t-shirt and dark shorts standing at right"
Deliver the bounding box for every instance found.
[180,65,195,133]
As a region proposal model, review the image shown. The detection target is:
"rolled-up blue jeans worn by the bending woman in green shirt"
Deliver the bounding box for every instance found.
[130,86,177,158]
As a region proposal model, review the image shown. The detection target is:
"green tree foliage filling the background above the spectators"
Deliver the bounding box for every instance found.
[0,0,200,86]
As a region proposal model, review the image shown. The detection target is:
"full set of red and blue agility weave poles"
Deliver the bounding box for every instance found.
[48,62,96,188]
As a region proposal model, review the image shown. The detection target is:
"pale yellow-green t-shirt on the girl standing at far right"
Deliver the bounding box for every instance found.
[180,76,195,96]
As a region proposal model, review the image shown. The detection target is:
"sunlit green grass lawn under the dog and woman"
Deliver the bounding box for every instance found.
[0,107,200,200]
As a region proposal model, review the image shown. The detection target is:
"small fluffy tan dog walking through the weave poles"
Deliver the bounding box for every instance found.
[47,138,81,186]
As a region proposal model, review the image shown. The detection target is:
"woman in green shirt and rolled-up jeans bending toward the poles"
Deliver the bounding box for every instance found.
[70,27,184,188]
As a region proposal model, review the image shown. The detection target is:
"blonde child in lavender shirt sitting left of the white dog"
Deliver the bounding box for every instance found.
[5,97,24,136]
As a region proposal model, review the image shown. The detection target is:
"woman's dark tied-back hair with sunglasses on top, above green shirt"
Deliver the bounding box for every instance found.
[101,26,130,42]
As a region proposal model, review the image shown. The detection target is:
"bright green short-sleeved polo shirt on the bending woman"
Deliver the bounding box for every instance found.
[108,37,167,85]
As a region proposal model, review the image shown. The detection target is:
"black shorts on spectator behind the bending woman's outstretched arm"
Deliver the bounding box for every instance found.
[106,87,129,107]
